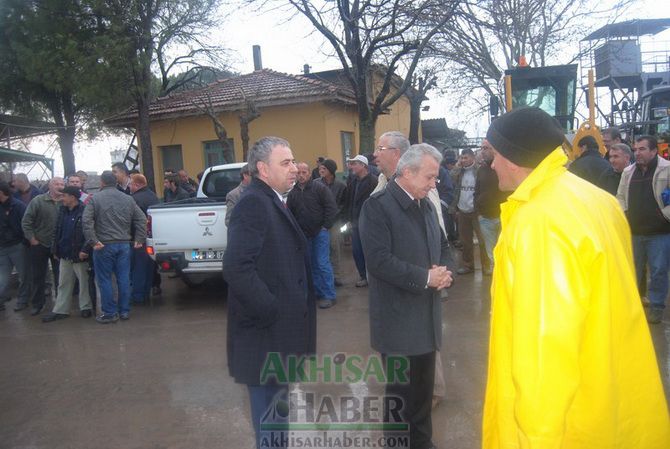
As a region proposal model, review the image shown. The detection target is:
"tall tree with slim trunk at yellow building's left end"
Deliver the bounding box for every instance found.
[97,0,227,188]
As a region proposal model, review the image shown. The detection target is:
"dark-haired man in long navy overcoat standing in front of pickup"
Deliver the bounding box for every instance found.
[223,137,316,447]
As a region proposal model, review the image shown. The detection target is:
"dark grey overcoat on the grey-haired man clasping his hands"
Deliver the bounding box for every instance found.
[358,181,451,355]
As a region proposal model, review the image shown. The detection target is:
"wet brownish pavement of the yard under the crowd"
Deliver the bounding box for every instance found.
[0,256,670,449]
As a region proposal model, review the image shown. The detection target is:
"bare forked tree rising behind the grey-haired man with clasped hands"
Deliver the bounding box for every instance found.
[248,0,460,153]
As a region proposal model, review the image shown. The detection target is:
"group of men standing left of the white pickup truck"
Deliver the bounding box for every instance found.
[0,163,202,324]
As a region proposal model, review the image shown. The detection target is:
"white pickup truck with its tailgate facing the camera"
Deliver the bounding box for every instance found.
[147,163,244,287]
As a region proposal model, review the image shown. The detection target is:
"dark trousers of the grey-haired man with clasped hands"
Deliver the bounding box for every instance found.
[382,352,435,449]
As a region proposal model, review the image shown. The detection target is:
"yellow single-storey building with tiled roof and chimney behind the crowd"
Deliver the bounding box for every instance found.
[105,69,410,185]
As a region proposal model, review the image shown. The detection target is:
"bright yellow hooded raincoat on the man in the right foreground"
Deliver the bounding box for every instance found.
[482,148,670,449]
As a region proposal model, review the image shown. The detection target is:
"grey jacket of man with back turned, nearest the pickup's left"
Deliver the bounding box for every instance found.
[84,186,147,245]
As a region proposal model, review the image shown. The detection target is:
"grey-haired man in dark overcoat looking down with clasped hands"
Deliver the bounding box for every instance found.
[359,144,452,449]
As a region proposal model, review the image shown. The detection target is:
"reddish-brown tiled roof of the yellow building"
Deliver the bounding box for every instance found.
[105,69,356,126]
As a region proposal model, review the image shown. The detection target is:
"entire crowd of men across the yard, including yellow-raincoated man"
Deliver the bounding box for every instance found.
[0,120,670,449]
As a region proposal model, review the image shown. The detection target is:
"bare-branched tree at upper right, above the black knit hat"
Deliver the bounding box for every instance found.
[431,0,633,117]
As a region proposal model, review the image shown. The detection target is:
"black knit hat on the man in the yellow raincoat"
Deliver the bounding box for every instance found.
[486,108,565,168]
